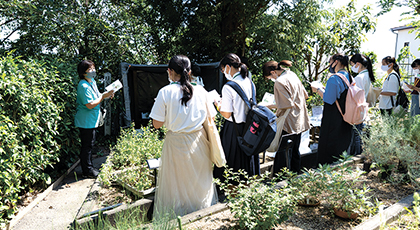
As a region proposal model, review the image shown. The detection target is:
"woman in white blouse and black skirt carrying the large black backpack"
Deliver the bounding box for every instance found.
[213,53,260,184]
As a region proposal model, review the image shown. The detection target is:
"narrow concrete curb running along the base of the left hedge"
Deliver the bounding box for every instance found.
[6,159,80,230]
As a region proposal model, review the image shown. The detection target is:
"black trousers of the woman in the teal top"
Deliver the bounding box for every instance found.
[79,128,96,174]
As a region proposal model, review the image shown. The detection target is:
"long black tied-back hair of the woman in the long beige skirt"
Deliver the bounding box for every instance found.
[168,55,193,106]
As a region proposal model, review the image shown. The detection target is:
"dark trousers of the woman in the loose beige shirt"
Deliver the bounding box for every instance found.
[273,130,302,176]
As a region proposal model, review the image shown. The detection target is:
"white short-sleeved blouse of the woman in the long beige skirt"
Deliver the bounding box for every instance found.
[150,83,217,133]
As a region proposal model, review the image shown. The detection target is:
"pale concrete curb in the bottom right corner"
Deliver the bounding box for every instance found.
[353,190,420,230]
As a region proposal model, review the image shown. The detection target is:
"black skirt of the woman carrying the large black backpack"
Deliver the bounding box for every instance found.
[213,120,260,181]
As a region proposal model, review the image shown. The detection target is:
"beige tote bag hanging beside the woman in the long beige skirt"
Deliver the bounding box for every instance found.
[203,103,226,168]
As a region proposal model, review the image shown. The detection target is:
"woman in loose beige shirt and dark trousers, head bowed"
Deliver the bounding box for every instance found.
[263,60,310,175]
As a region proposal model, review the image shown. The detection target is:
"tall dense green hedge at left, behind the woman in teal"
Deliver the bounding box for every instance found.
[0,54,78,224]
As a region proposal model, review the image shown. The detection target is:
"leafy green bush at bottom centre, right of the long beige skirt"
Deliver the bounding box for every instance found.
[219,169,296,229]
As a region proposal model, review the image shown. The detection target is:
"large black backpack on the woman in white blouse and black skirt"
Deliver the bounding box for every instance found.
[226,80,277,156]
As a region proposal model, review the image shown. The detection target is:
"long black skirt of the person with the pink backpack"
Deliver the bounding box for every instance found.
[318,89,353,164]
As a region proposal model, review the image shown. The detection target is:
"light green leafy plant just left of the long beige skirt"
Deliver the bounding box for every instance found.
[99,125,163,191]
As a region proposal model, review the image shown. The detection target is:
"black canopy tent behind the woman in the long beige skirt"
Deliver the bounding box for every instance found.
[121,62,224,129]
